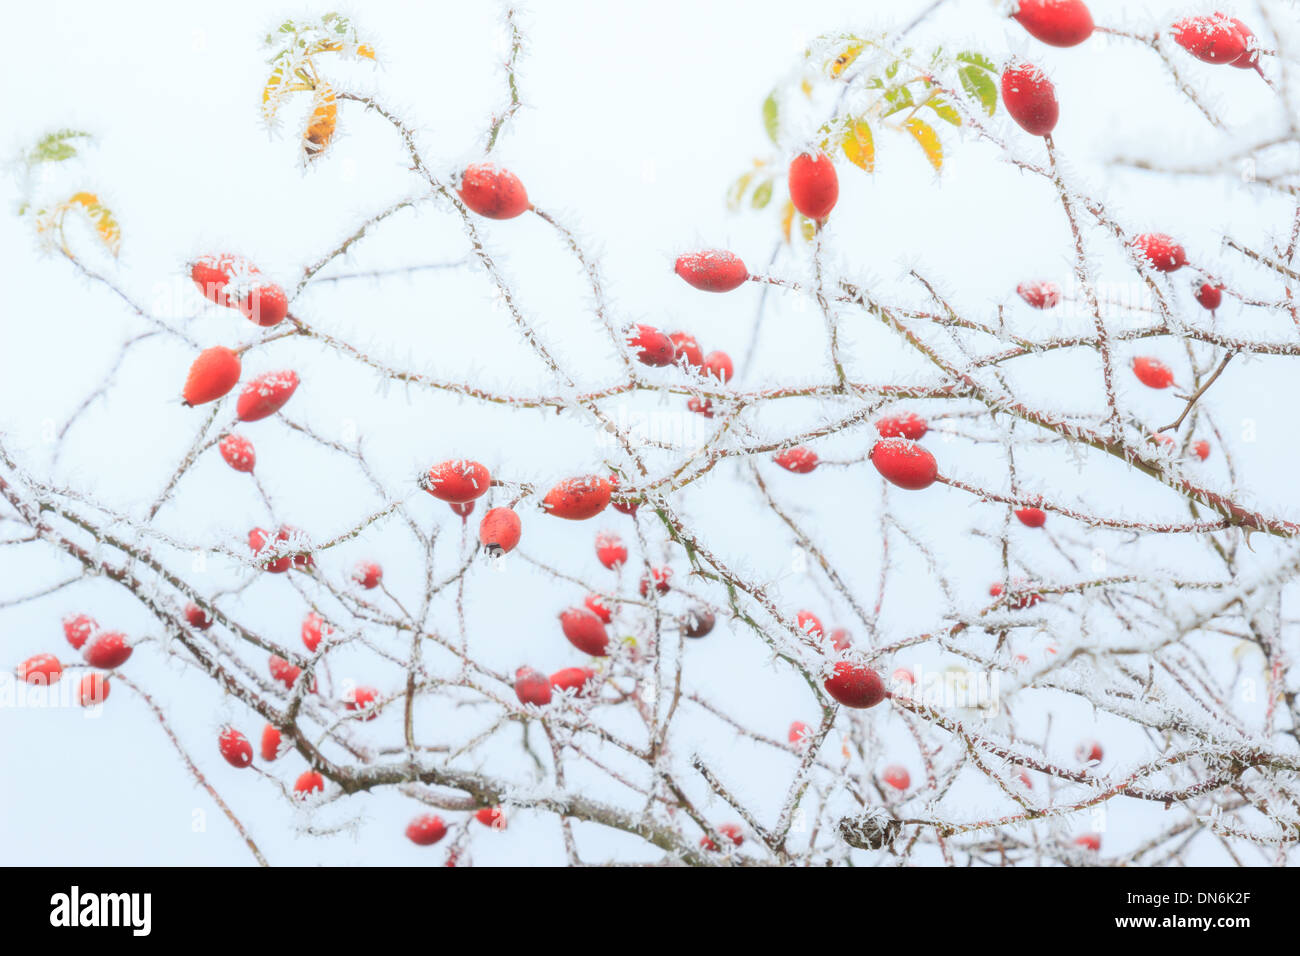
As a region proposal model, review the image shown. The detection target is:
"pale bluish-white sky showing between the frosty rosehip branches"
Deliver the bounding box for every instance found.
[0,0,1300,865]
